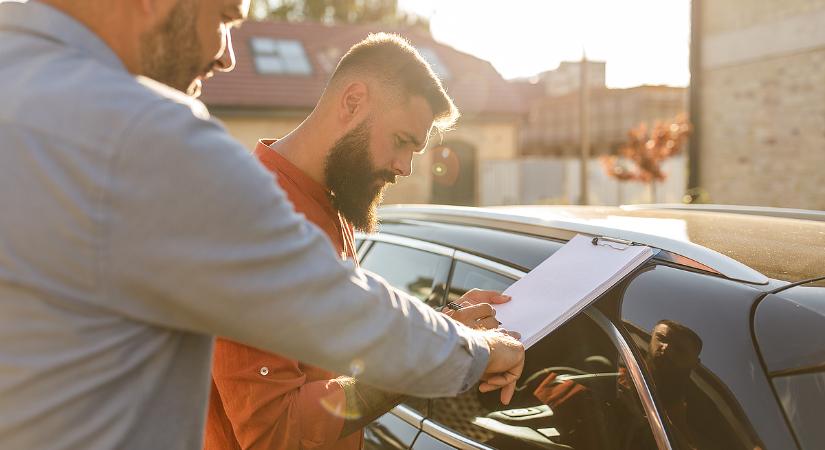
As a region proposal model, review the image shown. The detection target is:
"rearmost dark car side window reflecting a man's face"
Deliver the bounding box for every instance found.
[619,265,768,450]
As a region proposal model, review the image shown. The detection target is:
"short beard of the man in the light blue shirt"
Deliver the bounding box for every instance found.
[140,0,209,97]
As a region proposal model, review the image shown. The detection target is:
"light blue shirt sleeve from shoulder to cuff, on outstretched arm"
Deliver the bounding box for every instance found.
[103,92,489,397]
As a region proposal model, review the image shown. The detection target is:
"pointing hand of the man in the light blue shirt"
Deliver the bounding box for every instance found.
[478,331,524,405]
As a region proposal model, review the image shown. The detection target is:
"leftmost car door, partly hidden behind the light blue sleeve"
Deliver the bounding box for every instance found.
[359,234,453,449]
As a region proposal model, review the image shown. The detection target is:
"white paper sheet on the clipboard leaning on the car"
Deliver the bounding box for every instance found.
[496,235,654,348]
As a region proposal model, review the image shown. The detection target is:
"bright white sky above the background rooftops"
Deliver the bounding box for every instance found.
[399,0,690,88]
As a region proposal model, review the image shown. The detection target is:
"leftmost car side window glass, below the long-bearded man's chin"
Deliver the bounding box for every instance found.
[361,242,451,307]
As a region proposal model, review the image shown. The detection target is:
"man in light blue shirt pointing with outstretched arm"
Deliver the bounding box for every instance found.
[0,0,524,449]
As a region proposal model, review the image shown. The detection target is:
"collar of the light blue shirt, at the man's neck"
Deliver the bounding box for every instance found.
[0,0,126,71]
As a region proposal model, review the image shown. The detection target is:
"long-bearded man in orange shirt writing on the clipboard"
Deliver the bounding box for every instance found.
[205,34,511,450]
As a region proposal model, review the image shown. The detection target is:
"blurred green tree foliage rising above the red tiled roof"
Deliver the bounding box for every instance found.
[251,0,429,30]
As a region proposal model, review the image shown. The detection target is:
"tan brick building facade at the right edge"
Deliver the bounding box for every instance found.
[691,0,825,210]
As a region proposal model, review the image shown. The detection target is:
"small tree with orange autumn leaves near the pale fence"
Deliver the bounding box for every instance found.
[599,115,690,202]
